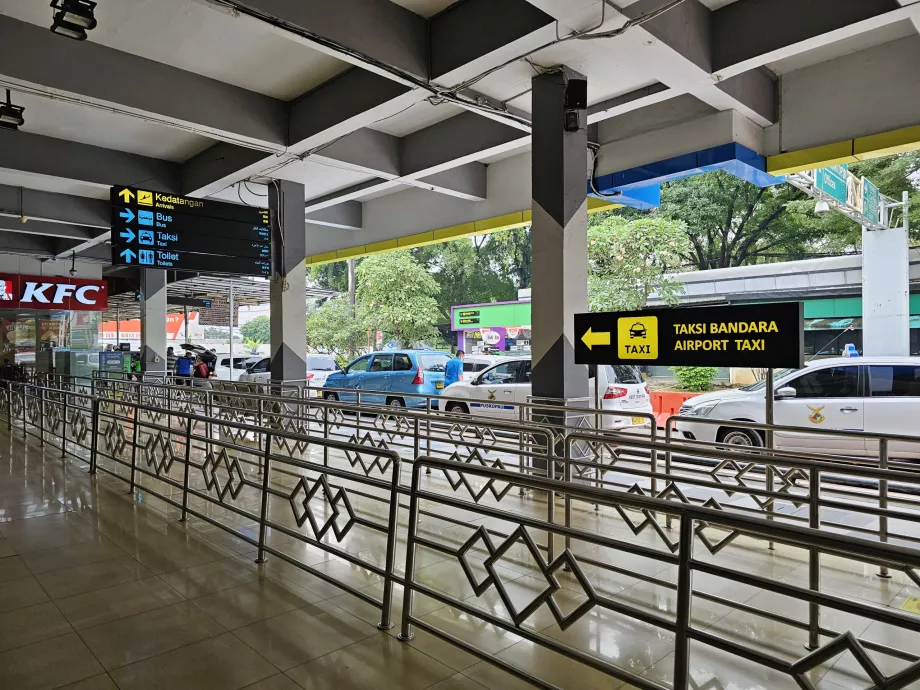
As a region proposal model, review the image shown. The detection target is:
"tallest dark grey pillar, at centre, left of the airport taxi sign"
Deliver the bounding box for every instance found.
[531,68,588,399]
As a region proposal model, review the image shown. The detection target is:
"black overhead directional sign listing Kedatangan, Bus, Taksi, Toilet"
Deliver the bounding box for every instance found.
[111,187,271,276]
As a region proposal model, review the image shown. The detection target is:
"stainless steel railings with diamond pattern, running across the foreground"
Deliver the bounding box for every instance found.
[0,381,920,688]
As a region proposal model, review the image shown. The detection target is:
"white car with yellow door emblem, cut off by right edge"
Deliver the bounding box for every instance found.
[677,357,920,458]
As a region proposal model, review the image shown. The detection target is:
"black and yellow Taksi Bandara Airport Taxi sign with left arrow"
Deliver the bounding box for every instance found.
[575,302,805,369]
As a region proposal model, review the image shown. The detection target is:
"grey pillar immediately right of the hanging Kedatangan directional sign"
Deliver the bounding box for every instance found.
[268,180,307,381]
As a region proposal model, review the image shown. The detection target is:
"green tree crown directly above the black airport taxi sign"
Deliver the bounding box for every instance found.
[588,215,690,311]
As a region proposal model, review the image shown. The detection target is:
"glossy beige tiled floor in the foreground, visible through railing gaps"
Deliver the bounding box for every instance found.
[0,422,920,690]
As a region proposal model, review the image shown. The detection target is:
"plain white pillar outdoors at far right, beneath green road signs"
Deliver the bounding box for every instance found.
[863,195,910,357]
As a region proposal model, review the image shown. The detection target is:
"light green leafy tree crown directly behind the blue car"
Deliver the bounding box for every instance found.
[357,251,440,347]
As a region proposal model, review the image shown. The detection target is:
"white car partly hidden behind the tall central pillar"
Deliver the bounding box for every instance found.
[442,357,652,429]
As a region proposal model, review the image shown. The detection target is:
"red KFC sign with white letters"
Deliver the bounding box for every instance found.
[0,274,109,311]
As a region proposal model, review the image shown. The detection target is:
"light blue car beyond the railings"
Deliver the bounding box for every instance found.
[323,350,450,407]
